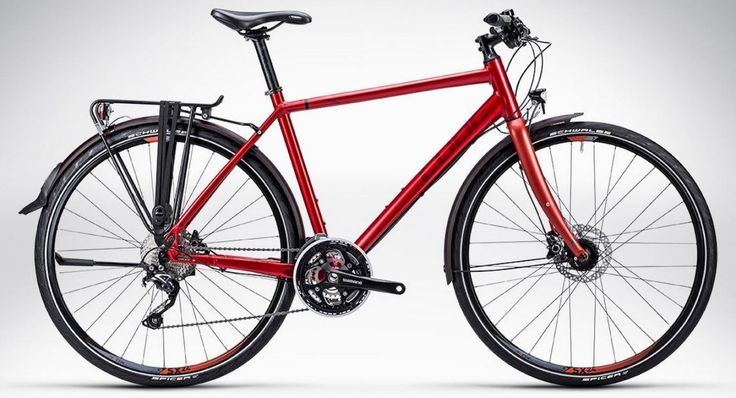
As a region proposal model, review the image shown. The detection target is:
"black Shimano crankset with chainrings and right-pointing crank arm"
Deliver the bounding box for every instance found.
[294,237,406,316]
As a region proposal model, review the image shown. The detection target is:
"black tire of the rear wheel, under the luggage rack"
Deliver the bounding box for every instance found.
[35,120,304,387]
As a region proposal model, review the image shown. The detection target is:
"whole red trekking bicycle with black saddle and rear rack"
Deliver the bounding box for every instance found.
[21,9,716,386]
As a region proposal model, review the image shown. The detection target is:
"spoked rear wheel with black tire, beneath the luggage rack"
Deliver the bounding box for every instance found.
[36,124,303,386]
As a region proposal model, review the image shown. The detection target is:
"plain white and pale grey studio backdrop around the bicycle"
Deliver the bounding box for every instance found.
[0,0,736,396]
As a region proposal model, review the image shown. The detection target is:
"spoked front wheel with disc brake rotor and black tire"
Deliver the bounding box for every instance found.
[446,122,716,385]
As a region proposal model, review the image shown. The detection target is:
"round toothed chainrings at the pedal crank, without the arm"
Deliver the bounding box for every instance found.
[294,238,372,316]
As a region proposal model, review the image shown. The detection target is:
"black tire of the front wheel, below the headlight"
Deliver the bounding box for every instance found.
[445,122,717,386]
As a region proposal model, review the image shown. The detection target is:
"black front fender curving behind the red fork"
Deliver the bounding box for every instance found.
[445,112,583,285]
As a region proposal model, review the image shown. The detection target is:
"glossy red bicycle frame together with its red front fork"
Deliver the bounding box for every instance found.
[169,58,586,278]
